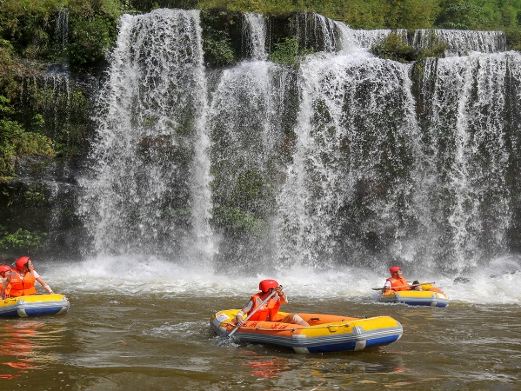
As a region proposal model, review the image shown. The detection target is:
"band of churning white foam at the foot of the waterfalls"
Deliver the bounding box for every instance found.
[39,257,521,304]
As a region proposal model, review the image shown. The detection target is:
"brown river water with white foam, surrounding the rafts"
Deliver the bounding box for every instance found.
[0,258,521,390]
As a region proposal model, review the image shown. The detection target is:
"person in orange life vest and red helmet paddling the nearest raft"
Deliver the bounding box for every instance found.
[235,280,309,327]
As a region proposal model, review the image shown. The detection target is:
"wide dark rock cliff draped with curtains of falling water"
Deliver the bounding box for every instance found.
[0,9,521,271]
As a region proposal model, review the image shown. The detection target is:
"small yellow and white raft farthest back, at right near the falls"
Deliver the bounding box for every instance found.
[379,284,449,307]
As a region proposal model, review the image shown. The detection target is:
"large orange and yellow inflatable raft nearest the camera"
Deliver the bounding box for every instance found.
[210,309,403,353]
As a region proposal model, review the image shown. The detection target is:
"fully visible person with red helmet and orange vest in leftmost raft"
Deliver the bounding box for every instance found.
[2,256,53,299]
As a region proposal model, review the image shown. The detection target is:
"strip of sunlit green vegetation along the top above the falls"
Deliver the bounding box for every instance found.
[198,0,521,30]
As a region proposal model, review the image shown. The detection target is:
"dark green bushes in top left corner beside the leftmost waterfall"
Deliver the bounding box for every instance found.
[0,0,123,68]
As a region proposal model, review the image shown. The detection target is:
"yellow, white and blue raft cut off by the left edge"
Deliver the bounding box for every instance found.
[0,293,70,318]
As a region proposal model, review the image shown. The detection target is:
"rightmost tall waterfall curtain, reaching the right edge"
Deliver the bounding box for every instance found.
[416,52,521,270]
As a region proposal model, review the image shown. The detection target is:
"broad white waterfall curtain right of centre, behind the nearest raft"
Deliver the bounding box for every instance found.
[277,53,417,267]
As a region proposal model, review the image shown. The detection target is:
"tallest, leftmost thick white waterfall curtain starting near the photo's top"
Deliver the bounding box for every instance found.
[80,9,215,262]
